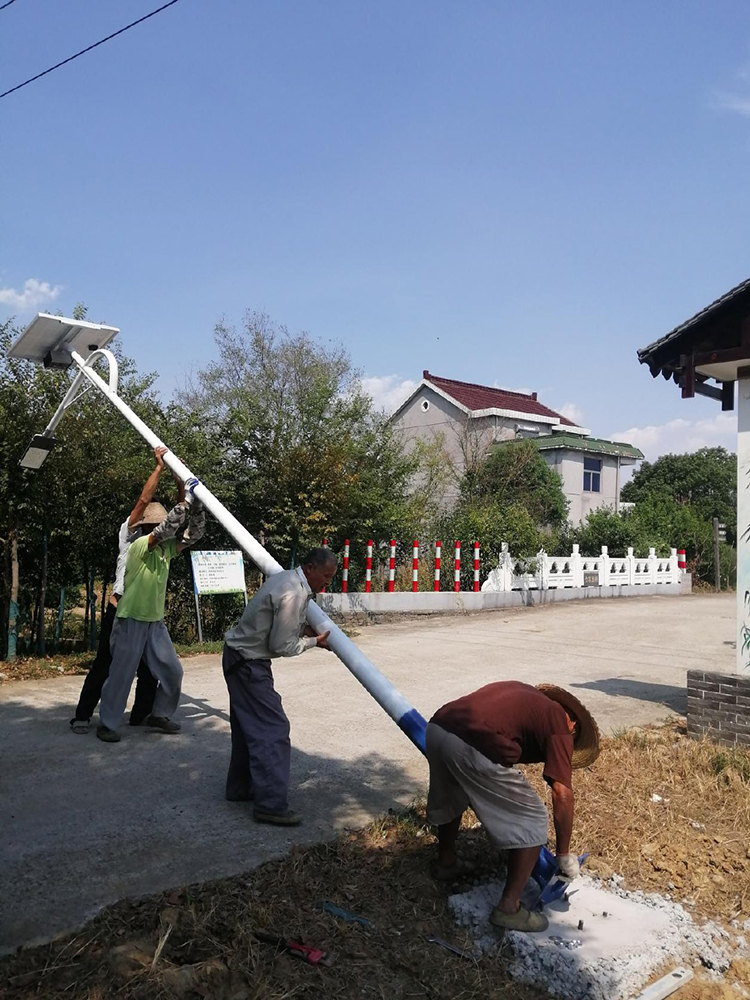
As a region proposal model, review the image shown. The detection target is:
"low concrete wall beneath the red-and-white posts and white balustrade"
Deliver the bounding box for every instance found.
[317,581,689,615]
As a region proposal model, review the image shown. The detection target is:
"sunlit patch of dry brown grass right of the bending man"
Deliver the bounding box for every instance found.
[564,723,750,920]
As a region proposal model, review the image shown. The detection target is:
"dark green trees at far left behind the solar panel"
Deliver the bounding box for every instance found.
[0,307,172,652]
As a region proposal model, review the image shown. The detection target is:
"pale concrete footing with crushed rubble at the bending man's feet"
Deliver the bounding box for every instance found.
[448,875,746,1000]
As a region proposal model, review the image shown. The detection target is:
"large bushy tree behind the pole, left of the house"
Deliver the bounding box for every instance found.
[170,313,426,562]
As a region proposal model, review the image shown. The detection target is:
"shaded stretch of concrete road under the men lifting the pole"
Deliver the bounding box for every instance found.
[0,690,422,951]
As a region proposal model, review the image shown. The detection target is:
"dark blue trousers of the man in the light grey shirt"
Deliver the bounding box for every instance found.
[222,645,291,813]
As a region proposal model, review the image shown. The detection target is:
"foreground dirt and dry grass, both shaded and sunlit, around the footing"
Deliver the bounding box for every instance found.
[0,720,750,1000]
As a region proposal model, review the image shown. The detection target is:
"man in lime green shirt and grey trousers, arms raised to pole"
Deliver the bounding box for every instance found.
[96,480,206,743]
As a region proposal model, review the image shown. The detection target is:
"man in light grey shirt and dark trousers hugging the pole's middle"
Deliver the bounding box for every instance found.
[222,548,337,826]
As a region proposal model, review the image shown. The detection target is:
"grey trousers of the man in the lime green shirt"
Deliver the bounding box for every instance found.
[99,618,182,729]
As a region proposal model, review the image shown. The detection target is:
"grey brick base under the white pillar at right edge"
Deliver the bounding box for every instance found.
[687,670,750,747]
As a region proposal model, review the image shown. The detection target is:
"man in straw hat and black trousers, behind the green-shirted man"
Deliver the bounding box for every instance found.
[70,447,185,734]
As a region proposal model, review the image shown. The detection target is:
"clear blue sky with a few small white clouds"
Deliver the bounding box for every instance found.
[0,0,750,455]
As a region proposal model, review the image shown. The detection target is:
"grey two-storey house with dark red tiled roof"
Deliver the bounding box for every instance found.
[391,370,643,524]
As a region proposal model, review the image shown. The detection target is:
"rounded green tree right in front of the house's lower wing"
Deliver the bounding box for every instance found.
[461,440,568,527]
